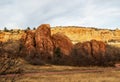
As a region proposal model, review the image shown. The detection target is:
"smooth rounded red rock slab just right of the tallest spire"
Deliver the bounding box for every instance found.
[52,33,73,56]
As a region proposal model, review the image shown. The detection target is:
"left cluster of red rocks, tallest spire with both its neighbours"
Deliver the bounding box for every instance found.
[22,24,73,63]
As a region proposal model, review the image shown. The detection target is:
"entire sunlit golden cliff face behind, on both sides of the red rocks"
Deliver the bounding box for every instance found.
[0,26,120,43]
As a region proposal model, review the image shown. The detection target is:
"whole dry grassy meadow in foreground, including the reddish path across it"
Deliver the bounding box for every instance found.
[11,60,120,82]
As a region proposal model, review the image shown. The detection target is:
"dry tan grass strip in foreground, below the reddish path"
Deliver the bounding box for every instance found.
[18,71,120,82]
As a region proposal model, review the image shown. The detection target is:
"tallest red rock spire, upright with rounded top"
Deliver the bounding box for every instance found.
[35,24,54,60]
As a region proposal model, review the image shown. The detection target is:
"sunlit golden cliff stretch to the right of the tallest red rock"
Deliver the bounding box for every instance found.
[52,27,120,43]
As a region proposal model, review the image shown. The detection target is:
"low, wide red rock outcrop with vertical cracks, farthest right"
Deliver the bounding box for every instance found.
[74,40,106,65]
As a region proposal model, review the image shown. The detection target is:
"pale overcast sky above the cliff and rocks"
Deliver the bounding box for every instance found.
[0,0,120,29]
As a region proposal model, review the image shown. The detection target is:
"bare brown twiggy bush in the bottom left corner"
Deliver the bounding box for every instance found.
[0,54,23,82]
